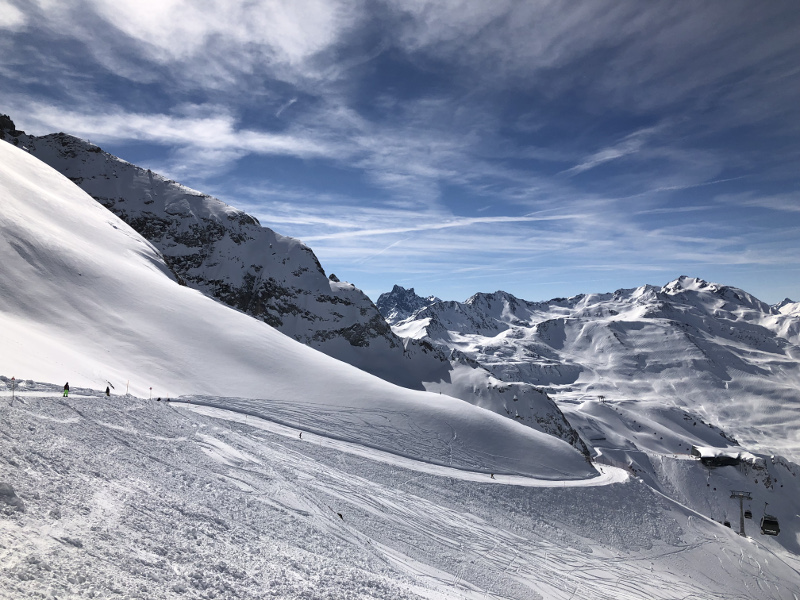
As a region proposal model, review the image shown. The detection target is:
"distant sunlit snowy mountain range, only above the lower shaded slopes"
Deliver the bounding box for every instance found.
[394,277,800,461]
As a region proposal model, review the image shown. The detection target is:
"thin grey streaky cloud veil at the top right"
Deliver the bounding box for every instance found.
[388,0,799,117]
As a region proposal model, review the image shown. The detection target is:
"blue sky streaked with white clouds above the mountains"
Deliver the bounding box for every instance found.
[0,0,800,303]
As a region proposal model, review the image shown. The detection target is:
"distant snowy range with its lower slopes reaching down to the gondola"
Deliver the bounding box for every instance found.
[386,277,800,552]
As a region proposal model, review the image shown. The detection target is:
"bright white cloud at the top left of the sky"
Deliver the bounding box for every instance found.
[10,0,364,88]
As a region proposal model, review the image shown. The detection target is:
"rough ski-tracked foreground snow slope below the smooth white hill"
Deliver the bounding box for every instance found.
[0,396,800,600]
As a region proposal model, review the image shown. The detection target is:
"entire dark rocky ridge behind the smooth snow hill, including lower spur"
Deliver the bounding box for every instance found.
[0,118,585,451]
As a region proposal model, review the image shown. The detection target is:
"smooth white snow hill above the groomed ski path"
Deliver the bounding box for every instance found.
[0,138,595,478]
